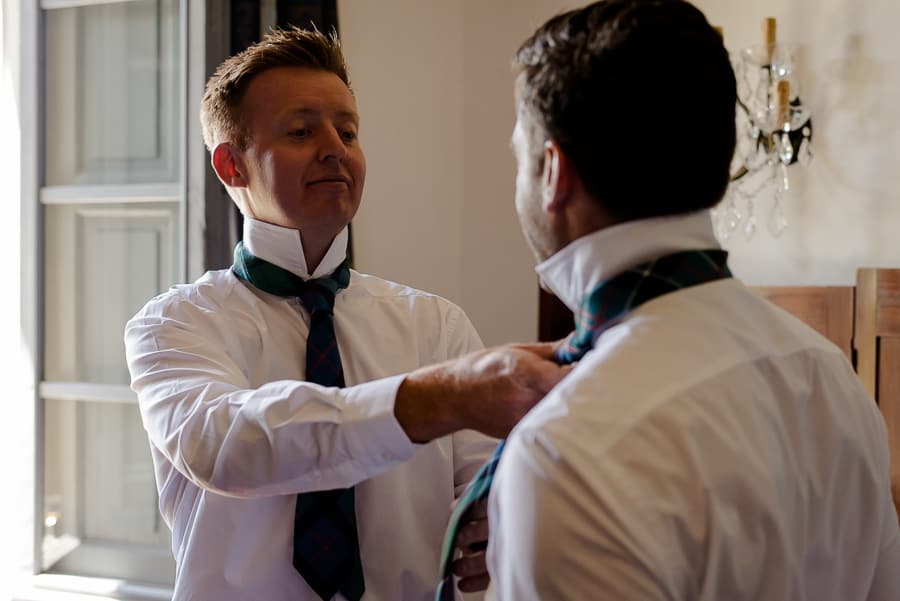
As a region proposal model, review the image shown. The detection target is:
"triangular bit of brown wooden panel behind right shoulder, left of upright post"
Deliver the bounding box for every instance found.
[754,286,853,362]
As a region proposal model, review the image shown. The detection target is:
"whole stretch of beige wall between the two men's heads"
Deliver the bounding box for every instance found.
[338,0,571,344]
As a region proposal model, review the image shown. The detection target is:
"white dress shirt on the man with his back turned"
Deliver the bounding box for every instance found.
[488,212,900,601]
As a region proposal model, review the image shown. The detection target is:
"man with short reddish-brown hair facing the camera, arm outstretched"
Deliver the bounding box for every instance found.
[125,29,563,601]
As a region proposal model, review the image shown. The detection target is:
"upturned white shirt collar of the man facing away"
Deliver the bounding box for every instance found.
[535,211,720,311]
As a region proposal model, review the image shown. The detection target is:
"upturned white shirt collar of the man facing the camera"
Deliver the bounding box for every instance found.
[244,217,349,280]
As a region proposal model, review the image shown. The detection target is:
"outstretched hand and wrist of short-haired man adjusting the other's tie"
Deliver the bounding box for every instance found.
[394,343,569,442]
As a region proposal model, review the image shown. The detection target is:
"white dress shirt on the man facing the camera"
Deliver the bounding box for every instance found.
[125,219,496,601]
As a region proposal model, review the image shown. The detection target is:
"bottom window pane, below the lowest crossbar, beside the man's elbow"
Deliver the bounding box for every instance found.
[43,399,174,584]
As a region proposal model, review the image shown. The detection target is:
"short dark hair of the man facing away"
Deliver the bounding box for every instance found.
[515,0,737,221]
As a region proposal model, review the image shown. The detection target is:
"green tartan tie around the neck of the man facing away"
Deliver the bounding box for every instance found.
[435,249,731,601]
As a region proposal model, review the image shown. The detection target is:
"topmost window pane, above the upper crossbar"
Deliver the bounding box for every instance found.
[45,0,181,185]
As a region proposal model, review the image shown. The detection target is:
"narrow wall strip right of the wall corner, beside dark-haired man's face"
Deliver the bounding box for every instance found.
[460,0,577,344]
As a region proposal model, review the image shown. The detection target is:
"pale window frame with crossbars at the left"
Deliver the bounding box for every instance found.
[10,0,230,601]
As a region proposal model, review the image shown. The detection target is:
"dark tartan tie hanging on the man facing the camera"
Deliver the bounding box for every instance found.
[232,242,366,601]
